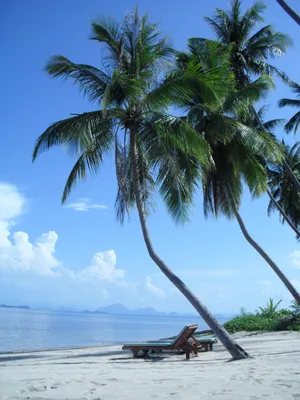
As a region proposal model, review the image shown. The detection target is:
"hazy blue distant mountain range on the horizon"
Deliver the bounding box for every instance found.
[95,303,196,317]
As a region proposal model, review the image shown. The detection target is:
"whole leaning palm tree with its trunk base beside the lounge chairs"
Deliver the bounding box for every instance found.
[33,9,248,359]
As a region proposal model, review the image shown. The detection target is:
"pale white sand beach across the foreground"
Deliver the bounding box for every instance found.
[0,332,300,400]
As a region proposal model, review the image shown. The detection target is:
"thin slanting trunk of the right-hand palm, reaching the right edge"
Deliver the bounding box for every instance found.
[234,208,300,304]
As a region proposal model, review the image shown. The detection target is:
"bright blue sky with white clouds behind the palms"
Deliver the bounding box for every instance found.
[0,0,300,313]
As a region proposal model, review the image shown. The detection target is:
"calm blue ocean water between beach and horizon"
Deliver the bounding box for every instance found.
[0,308,213,353]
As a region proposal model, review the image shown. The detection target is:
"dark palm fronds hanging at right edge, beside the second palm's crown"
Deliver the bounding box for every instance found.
[268,142,300,231]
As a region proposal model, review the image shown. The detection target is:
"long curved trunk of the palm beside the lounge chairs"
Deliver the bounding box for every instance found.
[130,129,248,360]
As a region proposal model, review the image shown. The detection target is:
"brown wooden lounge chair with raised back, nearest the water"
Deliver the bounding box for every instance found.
[122,325,200,360]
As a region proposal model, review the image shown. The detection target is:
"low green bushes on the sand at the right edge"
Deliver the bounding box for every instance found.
[224,299,300,333]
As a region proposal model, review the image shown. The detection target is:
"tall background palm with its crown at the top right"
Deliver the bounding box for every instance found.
[199,0,300,191]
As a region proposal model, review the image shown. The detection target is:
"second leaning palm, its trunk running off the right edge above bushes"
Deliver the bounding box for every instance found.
[178,41,300,303]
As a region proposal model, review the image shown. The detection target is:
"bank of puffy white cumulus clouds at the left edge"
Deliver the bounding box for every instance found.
[0,183,125,282]
